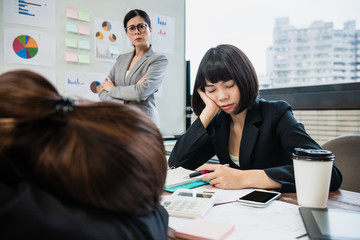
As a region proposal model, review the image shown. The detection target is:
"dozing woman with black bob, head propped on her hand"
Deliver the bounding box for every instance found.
[168,45,342,192]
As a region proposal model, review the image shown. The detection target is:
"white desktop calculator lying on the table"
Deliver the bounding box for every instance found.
[161,189,219,218]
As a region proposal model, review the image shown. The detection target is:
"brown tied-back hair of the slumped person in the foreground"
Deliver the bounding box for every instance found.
[0,70,167,215]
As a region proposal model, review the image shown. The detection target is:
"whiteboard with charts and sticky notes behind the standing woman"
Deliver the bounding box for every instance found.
[0,0,186,136]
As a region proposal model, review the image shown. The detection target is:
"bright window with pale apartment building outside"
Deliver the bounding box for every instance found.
[186,0,360,88]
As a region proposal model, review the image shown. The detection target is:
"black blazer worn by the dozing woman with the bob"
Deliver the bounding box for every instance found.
[168,99,342,192]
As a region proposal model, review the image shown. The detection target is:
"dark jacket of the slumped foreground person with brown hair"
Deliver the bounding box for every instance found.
[0,181,168,240]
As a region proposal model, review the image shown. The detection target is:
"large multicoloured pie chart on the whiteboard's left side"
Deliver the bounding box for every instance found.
[13,35,39,59]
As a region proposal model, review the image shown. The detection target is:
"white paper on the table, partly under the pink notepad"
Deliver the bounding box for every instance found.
[169,200,306,240]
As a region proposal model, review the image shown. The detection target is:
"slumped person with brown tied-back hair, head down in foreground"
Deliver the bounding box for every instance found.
[0,71,168,240]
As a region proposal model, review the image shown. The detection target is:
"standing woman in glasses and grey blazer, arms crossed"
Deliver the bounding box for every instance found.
[99,9,168,127]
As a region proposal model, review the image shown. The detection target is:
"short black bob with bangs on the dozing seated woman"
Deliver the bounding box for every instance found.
[192,44,259,116]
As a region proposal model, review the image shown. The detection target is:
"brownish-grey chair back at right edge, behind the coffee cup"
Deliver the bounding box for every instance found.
[322,133,360,192]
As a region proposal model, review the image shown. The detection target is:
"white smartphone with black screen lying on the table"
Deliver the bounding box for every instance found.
[237,190,281,207]
